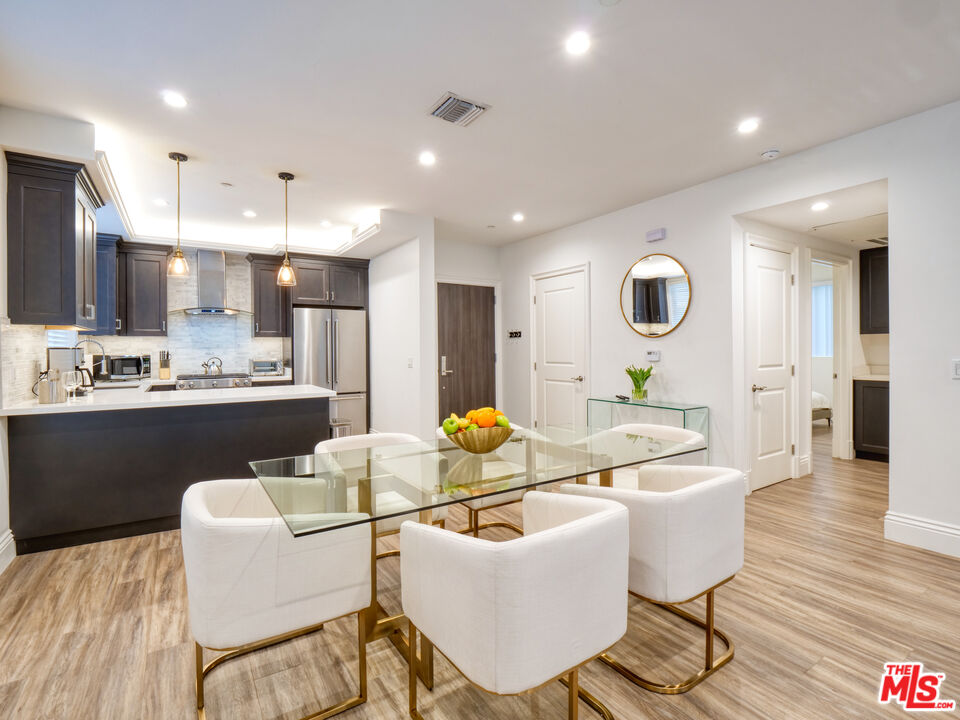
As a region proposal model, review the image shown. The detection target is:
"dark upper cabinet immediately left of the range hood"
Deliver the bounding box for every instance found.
[117,243,170,336]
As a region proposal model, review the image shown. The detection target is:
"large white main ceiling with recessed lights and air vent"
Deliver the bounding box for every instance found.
[0,0,960,253]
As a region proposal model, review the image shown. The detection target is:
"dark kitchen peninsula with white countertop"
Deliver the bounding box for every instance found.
[0,382,335,554]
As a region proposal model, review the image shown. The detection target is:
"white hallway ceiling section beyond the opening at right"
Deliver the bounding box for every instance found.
[740,180,888,249]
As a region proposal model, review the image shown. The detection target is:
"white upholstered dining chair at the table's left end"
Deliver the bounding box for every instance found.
[180,479,371,720]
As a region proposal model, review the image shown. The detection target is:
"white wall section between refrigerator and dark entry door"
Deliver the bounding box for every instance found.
[369,238,420,434]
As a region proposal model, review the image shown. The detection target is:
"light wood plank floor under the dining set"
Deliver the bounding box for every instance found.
[0,428,960,720]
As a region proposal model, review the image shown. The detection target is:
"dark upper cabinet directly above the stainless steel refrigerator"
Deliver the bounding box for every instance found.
[290,255,369,308]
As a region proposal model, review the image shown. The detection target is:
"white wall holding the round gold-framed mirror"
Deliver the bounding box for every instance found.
[500,103,960,556]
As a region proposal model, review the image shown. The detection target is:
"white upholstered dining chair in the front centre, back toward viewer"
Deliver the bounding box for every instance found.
[400,491,628,718]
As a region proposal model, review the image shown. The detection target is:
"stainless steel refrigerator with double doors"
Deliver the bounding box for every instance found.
[293,307,367,435]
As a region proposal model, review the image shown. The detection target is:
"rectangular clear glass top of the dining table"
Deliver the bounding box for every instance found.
[250,428,705,536]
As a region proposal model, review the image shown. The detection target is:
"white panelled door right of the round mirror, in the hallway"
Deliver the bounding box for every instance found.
[745,245,795,490]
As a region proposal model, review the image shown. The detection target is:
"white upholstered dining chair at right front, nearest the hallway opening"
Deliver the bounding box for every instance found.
[560,465,744,695]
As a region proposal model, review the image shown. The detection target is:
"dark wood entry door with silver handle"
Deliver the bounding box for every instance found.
[437,283,497,420]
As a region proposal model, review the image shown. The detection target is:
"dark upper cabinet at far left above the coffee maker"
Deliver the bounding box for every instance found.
[6,152,103,330]
